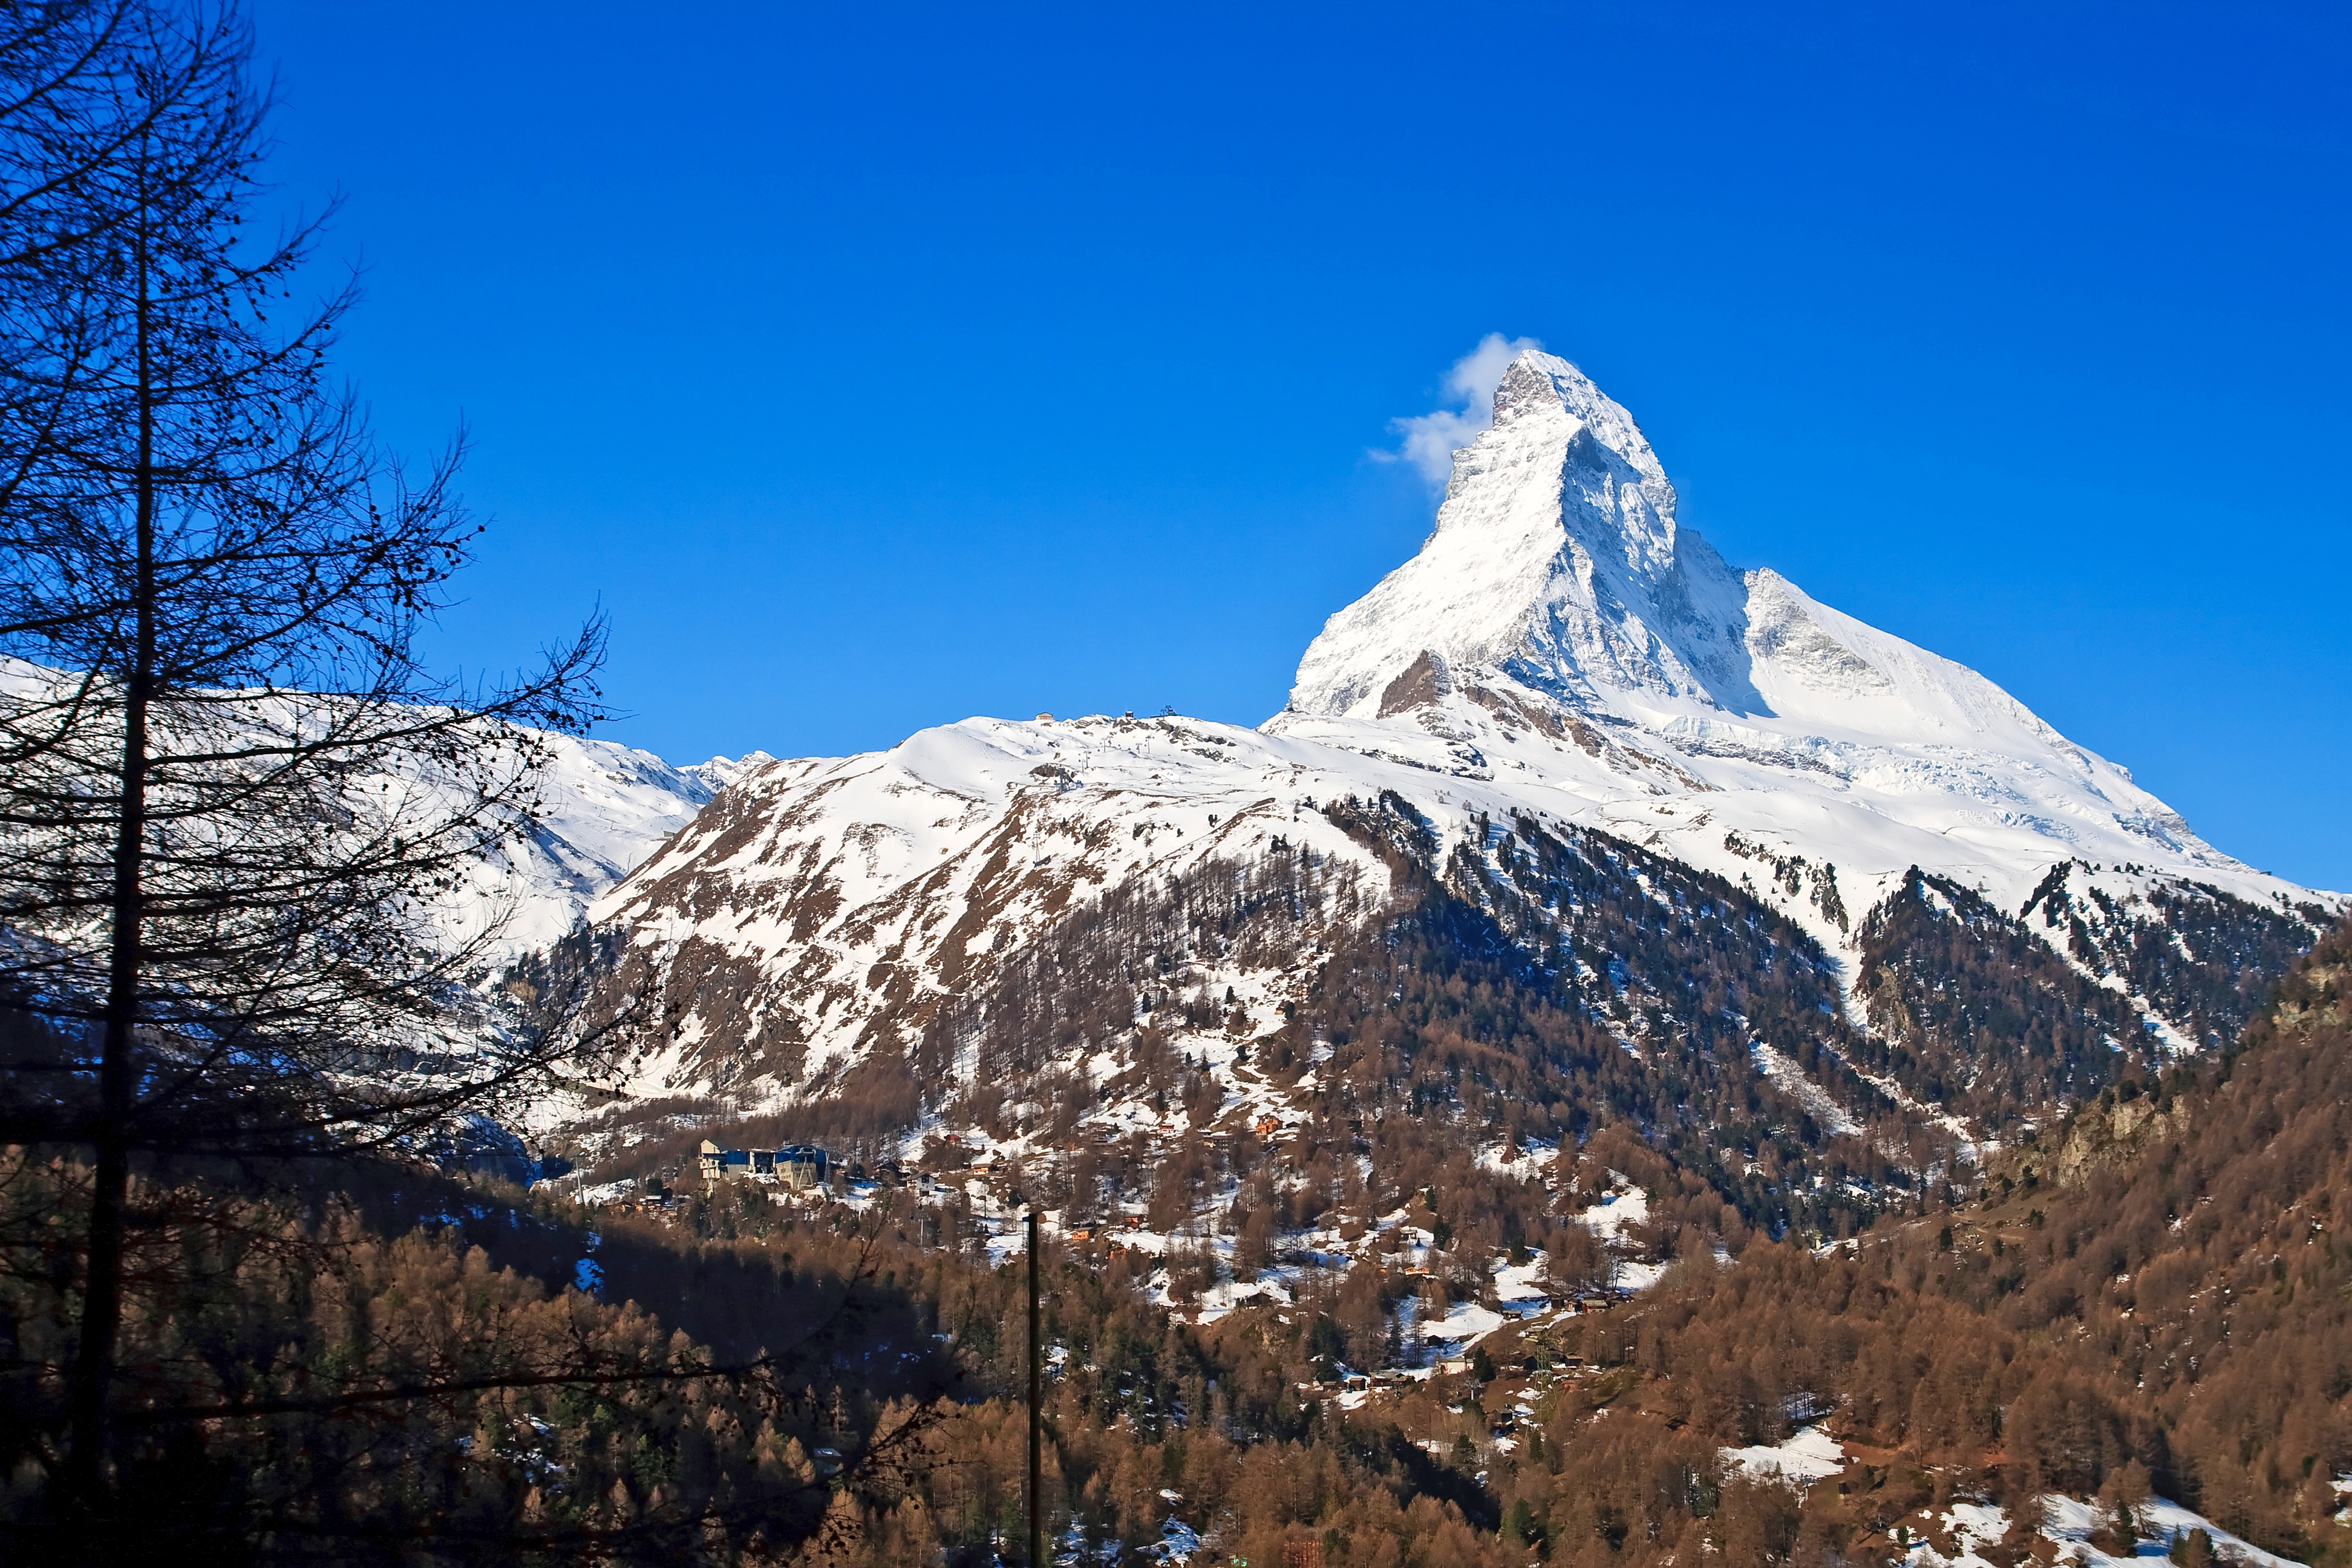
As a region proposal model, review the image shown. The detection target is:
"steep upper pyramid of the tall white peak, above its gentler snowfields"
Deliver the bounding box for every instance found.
[1289,350,2072,754]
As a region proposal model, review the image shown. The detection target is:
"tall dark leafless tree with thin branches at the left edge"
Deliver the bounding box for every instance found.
[0,0,602,1507]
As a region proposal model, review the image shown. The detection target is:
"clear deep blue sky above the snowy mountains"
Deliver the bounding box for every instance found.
[254,0,2352,889]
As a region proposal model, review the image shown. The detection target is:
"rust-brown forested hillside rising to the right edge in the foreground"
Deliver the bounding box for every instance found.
[1449,907,2352,1563]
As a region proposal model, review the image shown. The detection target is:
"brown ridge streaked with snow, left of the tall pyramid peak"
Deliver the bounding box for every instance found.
[590,717,1383,1093]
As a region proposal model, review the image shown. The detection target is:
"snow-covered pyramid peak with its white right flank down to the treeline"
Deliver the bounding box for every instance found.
[1266,350,2286,926]
